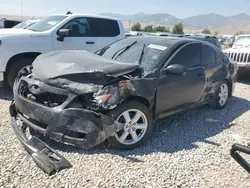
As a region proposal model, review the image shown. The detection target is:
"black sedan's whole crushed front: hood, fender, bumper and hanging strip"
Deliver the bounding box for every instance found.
[10,51,158,173]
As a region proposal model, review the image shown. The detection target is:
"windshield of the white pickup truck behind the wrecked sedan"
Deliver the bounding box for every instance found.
[26,16,67,32]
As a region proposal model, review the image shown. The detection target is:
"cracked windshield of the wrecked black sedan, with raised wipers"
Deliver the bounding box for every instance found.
[96,39,167,71]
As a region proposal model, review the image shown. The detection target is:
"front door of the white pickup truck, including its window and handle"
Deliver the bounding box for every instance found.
[53,17,97,52]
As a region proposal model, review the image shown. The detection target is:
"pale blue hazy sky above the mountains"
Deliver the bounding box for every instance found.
[0,0,250,18]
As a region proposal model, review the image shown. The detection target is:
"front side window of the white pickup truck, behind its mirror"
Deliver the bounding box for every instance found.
[62,18,90,37]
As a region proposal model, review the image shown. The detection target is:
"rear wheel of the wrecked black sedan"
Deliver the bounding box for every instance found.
[209,81,230,109]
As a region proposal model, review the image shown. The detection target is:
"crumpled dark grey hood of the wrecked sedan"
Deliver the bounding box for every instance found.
[32,50,140,88]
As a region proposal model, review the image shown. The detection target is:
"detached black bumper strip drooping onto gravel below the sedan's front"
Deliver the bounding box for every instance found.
[10,103,72,175]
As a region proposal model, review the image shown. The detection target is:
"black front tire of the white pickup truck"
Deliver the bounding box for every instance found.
[6,58,34,88]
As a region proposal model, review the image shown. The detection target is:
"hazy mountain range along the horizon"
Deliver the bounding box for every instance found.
[101,13,250,31]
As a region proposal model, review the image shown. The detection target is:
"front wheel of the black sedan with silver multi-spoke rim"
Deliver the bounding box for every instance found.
[107,101,153,149]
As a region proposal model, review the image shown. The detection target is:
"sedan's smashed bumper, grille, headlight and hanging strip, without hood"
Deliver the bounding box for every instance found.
[10,64,152,174]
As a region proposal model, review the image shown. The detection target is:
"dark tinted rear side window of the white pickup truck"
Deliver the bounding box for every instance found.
[89,18,120,37]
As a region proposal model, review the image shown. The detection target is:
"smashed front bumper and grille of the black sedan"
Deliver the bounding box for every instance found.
[12,74,127,149]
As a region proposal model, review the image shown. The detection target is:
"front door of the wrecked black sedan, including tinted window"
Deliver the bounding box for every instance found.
[156,43,205,118]
